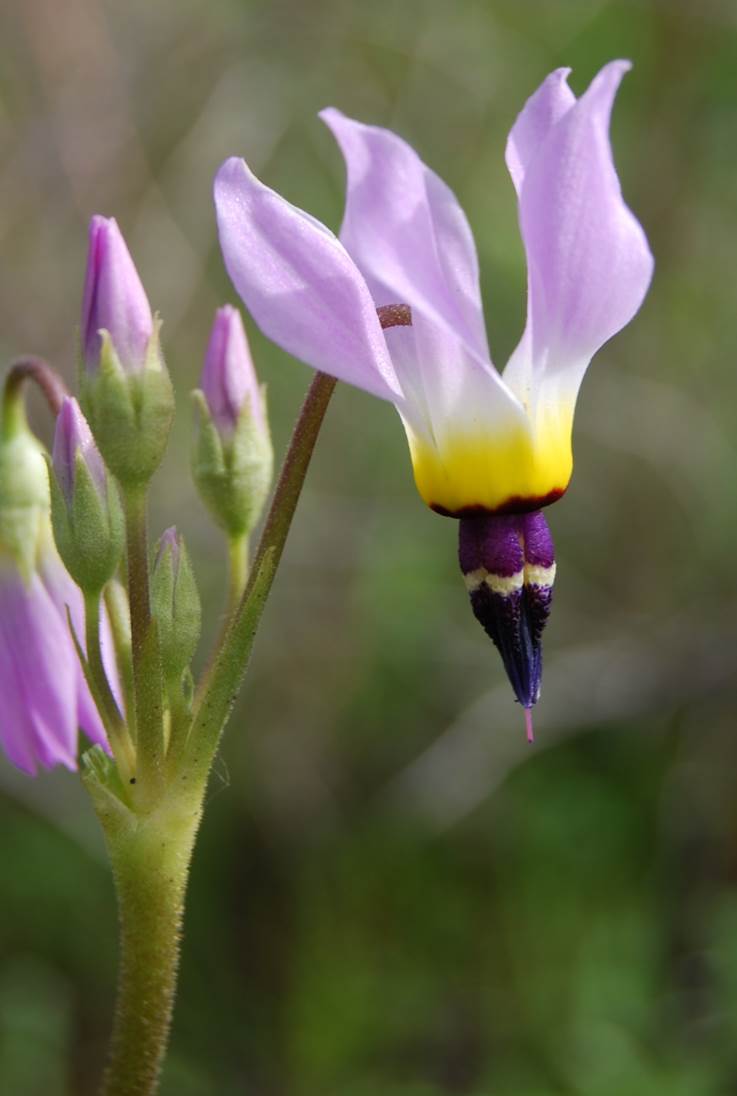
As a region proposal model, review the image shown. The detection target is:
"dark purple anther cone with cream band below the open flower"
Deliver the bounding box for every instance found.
[458,511,555,710]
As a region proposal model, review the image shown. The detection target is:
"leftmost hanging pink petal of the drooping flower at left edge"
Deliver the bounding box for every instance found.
[0,568,77,775]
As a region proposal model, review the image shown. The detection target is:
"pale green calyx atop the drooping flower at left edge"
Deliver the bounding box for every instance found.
[0,425,48,579]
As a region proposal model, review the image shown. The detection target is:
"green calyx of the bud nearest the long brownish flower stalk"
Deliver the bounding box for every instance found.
[192,389,274,537]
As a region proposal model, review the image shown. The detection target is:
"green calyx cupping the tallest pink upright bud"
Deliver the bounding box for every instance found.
[80,319,174,489]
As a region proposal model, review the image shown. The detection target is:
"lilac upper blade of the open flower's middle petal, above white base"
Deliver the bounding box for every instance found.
[320,107,489,364]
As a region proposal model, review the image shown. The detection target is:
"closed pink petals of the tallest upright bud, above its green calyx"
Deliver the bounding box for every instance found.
[81,216,154,374]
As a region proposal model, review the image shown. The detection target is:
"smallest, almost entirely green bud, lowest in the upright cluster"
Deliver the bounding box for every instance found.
[151,526,202,682]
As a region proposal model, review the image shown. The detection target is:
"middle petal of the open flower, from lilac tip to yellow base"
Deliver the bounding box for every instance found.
[321,110,530,501]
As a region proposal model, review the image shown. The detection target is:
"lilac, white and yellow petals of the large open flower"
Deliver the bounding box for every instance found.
[215,61,653,707]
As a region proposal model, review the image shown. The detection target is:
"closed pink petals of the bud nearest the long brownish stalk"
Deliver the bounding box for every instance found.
[200,305,267,437]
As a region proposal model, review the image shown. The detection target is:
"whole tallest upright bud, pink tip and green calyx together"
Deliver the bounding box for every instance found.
[81,217,174,488]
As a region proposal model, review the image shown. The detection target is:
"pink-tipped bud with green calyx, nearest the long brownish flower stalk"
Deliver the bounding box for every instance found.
[192,306,273,537]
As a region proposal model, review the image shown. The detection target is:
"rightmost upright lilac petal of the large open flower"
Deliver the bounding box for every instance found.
[504,61,653,411]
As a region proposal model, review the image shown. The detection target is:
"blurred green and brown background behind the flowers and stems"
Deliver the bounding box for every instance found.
[0,0,737,1096]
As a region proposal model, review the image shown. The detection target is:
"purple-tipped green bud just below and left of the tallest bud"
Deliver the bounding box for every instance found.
[49,397,123,593]
